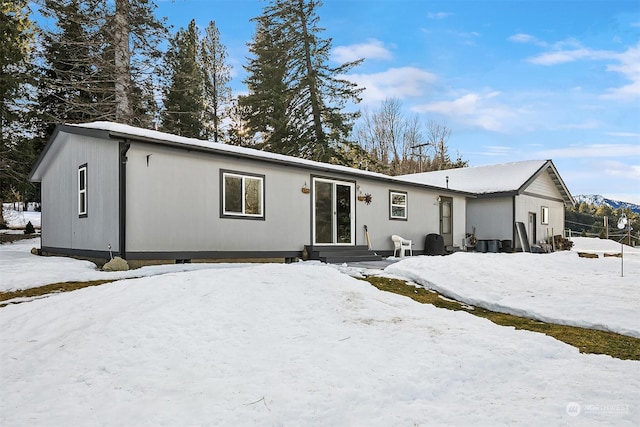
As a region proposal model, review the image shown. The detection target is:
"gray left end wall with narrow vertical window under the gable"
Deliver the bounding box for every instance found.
[42,133,119,252]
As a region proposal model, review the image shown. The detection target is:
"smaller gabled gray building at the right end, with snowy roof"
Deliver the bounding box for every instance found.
[402,160,574,254]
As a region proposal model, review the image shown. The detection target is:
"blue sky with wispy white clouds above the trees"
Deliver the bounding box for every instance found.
[158,0,640,203]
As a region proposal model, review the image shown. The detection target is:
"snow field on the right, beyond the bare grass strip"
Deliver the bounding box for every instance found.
[384,237,640,337]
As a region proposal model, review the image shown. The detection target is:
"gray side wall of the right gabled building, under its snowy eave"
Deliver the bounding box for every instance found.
[467,197,514,240]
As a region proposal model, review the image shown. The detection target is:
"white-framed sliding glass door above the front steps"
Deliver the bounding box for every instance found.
[312,178,356,246]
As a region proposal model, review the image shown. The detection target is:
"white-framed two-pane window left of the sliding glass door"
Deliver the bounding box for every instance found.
[221,171,264,219]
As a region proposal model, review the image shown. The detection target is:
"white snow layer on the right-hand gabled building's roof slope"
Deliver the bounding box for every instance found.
[401,160,547,194]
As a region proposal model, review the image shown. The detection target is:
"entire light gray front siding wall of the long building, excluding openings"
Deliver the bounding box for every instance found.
[127,143,466,252]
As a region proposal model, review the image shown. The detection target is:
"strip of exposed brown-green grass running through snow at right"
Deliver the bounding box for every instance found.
[364,276,640,360]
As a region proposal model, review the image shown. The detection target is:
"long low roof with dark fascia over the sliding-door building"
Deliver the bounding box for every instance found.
[29,122,474,197]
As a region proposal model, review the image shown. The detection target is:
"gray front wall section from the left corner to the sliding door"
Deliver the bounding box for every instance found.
[127,144,310,252]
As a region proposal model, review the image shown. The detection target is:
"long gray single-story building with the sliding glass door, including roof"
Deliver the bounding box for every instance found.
[30,122,476,265]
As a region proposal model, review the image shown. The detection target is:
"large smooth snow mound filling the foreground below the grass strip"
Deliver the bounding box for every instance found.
[0,262,640,426]
